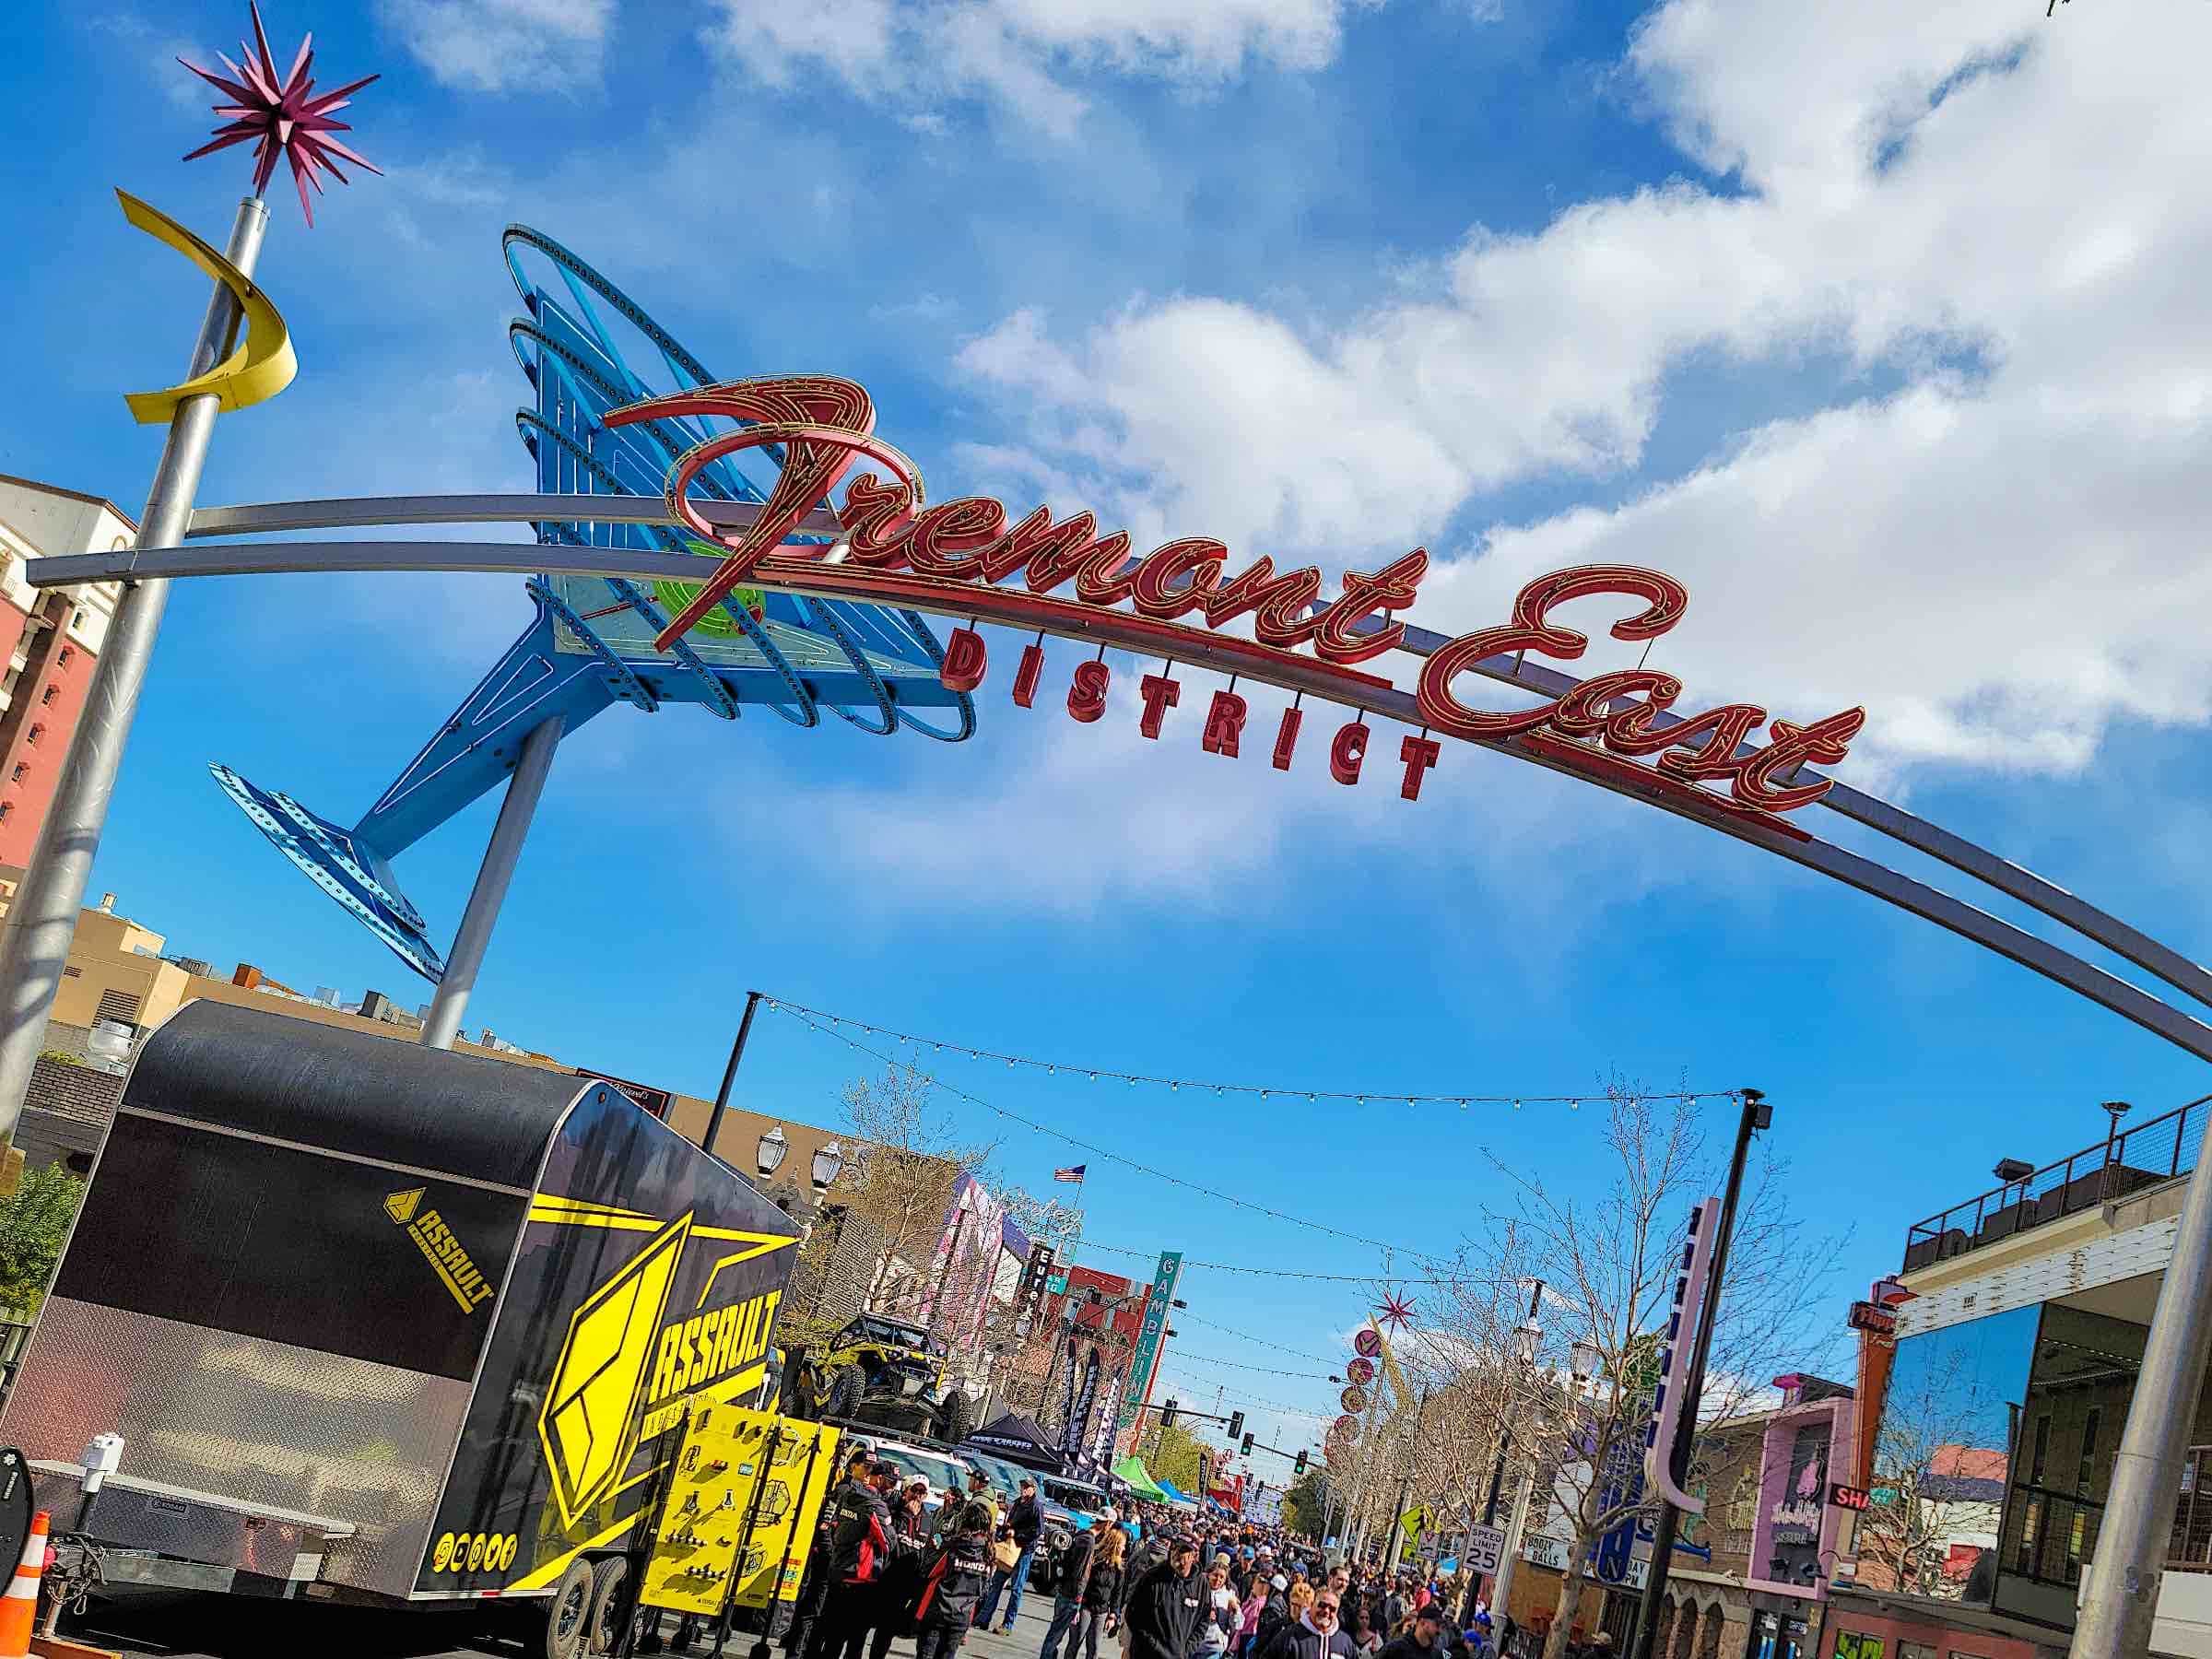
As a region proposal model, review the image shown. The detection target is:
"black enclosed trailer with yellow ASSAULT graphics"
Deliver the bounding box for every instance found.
[0,1002,796,1653]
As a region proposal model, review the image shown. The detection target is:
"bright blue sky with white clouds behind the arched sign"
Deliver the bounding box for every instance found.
[0,0,2212,1433]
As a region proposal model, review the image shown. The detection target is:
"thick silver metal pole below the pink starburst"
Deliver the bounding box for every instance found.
[0,197,270,1146]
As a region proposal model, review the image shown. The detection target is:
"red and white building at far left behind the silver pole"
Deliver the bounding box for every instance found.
[0,474,137,865]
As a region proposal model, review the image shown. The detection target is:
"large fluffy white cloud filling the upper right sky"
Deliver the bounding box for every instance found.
[960,0,2212,770]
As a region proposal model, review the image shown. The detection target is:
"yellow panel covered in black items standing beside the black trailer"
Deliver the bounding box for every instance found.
[641,1395,839,1617]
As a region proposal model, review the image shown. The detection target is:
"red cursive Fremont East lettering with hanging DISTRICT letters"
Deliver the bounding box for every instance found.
[606,376,1867,823]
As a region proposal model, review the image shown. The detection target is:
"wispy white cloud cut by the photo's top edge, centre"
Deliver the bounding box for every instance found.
[706,0,1378,139]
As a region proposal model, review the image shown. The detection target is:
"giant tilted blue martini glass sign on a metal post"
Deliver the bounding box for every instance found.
[208,226,975,1044]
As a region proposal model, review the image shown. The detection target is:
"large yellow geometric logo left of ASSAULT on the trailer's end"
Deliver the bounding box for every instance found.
[537,1215,690,1526]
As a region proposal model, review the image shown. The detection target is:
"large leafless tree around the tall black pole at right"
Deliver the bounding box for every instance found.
[1431,1082,1836,1659]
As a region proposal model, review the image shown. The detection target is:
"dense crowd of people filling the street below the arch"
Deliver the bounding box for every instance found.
[783,1451,1613,1659]
